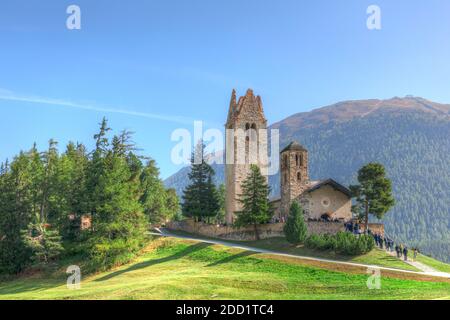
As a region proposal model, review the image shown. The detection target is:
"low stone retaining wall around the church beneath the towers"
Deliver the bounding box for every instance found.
[167,219,344,241]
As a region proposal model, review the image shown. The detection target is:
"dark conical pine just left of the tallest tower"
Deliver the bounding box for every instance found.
[182,142,220,221]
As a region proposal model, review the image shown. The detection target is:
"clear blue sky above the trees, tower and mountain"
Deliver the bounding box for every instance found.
[0,0,450,178]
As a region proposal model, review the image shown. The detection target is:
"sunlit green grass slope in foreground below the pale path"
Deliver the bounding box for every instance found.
[0,238,450,299]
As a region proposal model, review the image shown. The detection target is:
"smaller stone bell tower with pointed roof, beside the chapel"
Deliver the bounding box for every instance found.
[280,141,309,217]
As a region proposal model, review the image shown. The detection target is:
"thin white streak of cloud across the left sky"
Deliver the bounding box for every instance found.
[0,88,194,125]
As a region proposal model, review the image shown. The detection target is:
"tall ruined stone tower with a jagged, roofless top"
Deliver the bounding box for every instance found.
[225,89,268,224]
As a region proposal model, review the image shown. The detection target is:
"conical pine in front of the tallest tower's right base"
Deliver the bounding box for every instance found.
[235,165,272,240]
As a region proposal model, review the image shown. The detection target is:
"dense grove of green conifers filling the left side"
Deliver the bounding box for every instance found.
[0,119,180,274]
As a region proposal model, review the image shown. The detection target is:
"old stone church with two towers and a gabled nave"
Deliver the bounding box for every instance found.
[225,89,352,224]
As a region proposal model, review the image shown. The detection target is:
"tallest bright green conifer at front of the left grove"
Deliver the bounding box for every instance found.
[88,123,147,269]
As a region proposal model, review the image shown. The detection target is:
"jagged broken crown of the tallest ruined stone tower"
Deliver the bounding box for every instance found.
[226,89,267,128]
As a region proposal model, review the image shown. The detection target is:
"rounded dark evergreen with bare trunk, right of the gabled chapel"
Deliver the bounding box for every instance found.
[350,163,395,232]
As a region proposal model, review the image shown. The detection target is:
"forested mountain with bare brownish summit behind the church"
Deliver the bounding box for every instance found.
[165,96,450,262]
